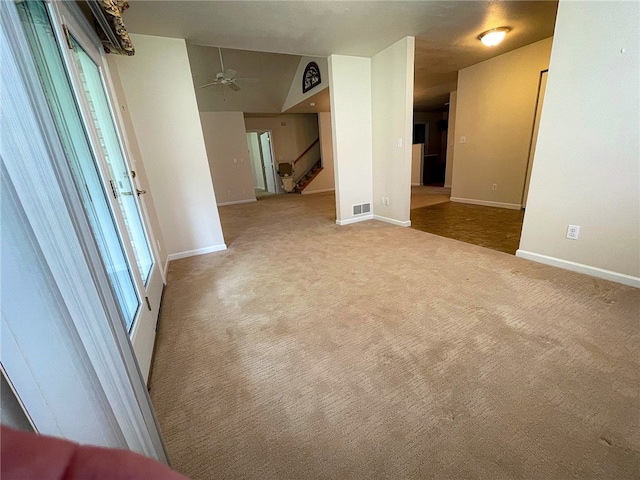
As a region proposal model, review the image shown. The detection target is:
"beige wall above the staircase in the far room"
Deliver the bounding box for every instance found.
[245,113,320,178]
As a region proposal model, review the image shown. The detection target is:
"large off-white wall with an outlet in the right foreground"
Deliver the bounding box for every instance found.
[516,0,640,286]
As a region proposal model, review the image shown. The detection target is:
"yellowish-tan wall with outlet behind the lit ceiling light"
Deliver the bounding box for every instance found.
[451,38,552,208]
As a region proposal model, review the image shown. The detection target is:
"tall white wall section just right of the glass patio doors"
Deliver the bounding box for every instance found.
[113,34,226,259]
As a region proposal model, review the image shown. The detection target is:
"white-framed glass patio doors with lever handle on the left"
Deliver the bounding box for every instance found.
[18,2,163,381]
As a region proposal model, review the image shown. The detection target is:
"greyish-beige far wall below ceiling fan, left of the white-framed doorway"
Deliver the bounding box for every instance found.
[200,112,256,205]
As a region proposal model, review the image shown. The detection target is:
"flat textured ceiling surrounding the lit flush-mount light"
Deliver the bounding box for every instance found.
[124,0,557,111]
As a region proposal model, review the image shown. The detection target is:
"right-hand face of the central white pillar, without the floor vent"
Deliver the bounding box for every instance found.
[371,37,415,226]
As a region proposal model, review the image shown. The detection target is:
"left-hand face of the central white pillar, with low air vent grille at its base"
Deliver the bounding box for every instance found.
[329,55,373,225]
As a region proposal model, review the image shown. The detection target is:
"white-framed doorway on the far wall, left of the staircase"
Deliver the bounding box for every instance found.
[247,130,282,199]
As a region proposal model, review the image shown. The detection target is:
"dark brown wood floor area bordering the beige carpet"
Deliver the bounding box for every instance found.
[411,187,524,255]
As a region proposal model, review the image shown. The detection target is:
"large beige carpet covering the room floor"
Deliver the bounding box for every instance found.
[151,194,640,480]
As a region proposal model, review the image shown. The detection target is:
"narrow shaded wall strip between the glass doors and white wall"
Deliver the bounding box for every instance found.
[107,55,168,272]
